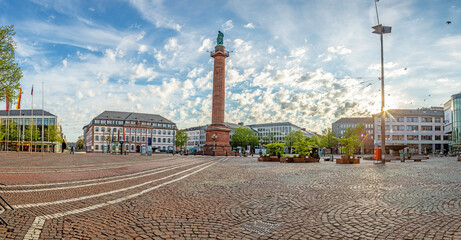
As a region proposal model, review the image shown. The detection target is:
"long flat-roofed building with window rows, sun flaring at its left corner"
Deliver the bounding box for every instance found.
[373,107,451,154]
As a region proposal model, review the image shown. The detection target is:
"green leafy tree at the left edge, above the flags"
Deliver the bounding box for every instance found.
[0,25,22,102]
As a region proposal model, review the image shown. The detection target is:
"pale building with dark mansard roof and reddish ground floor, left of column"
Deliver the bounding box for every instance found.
[83,111,177,153]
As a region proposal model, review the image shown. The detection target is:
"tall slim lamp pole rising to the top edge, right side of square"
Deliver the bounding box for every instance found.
[372,0,392,164]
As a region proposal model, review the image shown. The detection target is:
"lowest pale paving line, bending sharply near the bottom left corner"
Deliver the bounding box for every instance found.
[24,159,218,240]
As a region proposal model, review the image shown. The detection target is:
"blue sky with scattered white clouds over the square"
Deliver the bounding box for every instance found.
[0,0,461,141]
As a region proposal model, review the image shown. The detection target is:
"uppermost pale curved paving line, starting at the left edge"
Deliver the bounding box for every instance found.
[0,160,201,193]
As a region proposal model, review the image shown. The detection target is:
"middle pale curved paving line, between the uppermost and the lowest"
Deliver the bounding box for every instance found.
[13,162,209,209]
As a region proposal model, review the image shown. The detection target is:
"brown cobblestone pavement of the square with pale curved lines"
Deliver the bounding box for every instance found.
[0,153,461,239]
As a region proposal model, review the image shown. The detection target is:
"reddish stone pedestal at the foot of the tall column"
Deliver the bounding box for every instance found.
[203,124,233,156]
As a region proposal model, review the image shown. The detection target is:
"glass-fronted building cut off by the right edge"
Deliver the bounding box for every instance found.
[444,93,461,152]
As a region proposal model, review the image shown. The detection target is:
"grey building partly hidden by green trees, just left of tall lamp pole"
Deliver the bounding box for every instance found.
[331,117,374,154]
